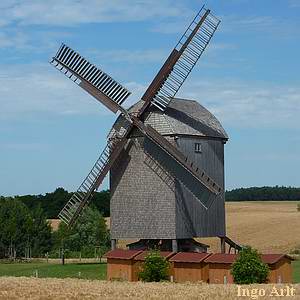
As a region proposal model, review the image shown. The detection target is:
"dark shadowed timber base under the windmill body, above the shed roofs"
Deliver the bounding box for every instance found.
[123,239,209,253]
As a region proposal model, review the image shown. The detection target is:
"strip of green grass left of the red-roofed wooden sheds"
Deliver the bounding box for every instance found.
[0,262,106,280]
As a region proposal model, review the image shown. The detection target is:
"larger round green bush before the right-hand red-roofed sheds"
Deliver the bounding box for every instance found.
[231,247,269,284]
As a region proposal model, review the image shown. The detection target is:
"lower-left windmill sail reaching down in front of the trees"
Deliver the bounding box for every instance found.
[58,136,127,227]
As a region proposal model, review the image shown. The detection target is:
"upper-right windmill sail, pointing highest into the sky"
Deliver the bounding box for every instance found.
[140,6,220,115]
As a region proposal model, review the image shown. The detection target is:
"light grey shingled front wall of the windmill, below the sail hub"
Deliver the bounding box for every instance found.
[110,138,176,239]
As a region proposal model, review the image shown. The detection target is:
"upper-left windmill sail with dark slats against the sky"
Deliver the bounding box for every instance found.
[50,44,131,113]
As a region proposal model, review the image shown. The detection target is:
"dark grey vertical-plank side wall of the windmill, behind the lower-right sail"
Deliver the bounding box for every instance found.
[176,137,226,238]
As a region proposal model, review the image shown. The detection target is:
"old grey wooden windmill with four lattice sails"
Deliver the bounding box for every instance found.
[51,6,240,251]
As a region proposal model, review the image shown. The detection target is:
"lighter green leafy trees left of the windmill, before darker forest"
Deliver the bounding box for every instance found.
[0,197,110,259]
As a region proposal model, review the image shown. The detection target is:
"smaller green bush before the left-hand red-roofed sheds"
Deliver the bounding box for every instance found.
[139,250,169,282]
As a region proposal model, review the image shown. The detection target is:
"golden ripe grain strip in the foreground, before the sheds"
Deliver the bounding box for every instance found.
[0,277,300,300]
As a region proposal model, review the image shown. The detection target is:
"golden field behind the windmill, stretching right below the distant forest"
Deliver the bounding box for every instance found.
[107,201,300,253]
